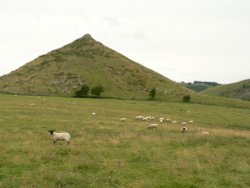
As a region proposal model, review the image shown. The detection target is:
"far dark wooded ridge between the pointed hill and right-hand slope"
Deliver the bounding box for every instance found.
[180,81,221,92]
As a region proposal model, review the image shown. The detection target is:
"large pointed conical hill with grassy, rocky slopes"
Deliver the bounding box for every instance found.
[0,34,192,100]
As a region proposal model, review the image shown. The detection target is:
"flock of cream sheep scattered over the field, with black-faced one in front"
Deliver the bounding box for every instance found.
[48,112,209,144]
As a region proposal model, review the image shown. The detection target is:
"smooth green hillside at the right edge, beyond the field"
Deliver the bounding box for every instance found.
[201,79,250,101]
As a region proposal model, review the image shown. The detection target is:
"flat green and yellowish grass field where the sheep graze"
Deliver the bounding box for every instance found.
[0,95,250,188]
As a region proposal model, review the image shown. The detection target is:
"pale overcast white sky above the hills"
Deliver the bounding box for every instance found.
[0,0,250,84]
